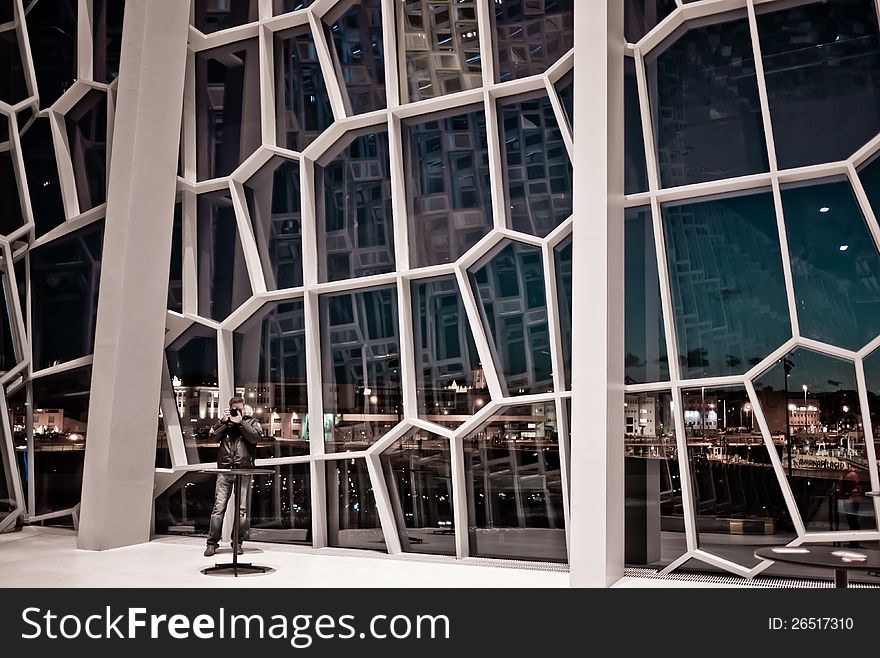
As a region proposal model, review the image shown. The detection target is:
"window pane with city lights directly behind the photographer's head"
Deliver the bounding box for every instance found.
[233,299,309,458]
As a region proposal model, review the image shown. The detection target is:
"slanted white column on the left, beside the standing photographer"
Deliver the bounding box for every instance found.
[77,0,190,550]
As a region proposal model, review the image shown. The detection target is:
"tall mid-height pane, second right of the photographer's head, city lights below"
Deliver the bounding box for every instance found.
[320,287,403,452]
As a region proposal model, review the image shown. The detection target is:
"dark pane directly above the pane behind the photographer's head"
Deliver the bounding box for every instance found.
[244,156,303,290]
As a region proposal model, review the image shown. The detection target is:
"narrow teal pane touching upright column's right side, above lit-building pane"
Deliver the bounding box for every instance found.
[624,206,669,384]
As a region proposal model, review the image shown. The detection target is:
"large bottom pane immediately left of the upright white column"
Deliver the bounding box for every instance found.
[464,402,567,562]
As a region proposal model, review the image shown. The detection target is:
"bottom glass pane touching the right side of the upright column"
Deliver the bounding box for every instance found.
[623,391,687,569]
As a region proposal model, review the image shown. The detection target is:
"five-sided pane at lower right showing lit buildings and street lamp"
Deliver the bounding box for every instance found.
[755,348,877,532]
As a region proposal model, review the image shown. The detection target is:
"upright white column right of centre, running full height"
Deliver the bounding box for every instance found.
[569,0,624,587]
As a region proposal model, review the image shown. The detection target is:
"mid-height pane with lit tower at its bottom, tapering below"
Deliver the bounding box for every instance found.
[411,275,490,427]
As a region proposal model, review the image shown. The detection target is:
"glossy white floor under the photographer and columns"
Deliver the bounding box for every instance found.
[0,527,744,588]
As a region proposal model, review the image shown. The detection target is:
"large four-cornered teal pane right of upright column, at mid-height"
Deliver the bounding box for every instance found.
[662,191,791,377]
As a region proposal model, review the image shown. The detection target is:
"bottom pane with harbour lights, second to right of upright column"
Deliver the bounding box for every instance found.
[682,386,797,568]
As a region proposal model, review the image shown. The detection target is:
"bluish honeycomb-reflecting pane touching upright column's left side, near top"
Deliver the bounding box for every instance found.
[498,93,572,237]
